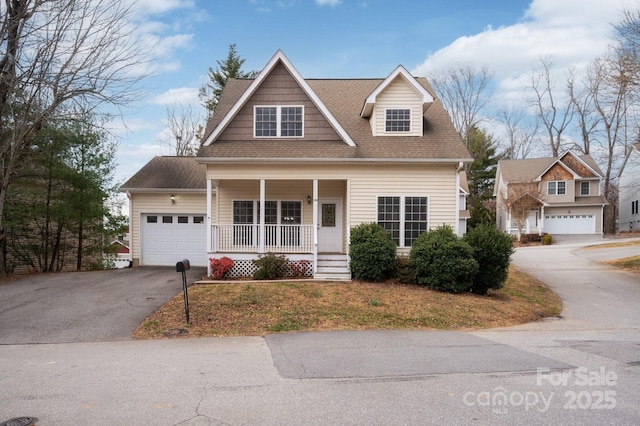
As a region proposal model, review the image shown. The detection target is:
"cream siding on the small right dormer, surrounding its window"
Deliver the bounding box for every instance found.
[370,76,423,136]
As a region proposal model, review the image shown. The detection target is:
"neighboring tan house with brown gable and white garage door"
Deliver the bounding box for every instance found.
[493,152,608,235]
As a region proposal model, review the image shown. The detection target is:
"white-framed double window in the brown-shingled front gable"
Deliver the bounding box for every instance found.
[254,105,304,138]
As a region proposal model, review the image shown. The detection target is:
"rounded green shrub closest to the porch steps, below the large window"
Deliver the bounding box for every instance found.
[349,223,396,281]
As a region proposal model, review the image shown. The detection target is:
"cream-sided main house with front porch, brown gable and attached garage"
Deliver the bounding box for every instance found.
[121,51,472,279]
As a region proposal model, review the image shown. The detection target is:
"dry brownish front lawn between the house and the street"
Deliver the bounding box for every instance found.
[134,268,562,339]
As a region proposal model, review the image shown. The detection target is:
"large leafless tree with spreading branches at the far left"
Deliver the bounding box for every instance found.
[0,0,148,267]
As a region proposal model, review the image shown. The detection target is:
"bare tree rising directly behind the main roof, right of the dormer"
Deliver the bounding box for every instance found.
[431,65,493,147]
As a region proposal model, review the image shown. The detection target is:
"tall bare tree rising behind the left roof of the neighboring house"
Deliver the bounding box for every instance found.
[530,58,574,157]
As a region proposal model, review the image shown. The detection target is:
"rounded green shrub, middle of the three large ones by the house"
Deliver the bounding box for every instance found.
[411,226,478,293]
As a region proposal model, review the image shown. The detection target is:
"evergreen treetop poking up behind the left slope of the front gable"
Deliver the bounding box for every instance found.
[198,44,258,117]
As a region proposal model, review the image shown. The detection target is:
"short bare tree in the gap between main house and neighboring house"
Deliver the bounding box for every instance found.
[497,107,540,160]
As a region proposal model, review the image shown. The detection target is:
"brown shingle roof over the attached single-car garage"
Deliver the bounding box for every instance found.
[120,157,207,192]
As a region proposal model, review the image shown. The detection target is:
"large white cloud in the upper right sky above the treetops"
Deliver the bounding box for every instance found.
[413,0,629,78]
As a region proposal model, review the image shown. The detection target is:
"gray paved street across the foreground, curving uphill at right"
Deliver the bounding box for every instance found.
[0,238,640,425]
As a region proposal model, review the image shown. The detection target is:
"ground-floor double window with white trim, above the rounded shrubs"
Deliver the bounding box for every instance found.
[378,196,429,247]
